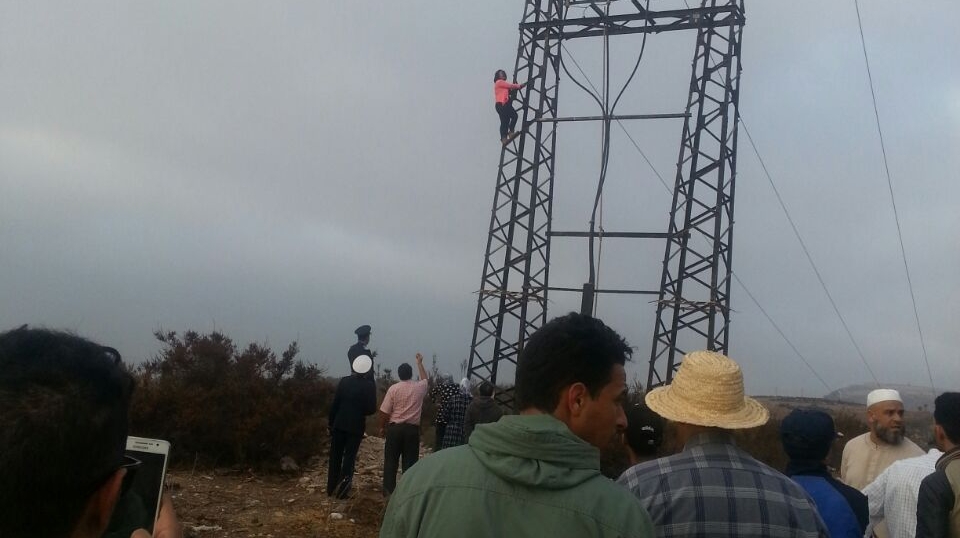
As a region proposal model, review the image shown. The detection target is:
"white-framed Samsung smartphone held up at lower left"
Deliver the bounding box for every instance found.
[104,437,170,537]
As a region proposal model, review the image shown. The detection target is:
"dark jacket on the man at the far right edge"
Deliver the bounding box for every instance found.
[917,447,960,538]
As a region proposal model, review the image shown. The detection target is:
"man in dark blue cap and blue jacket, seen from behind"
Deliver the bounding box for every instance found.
[780,409,869,538]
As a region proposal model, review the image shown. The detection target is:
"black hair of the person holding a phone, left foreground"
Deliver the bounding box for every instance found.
[0,326,133,538]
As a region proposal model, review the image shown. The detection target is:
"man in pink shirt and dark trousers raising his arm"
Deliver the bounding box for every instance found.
[379,353,429,495]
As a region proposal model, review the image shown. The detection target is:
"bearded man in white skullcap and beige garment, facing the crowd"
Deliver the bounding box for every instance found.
[840,389,923,490]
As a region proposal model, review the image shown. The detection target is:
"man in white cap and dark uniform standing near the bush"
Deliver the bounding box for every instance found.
[327,355,377,499]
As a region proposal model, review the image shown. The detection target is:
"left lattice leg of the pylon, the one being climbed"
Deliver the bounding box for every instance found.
[468,0,563,404]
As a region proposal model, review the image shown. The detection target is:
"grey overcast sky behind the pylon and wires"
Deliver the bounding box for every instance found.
[0,0,960,396]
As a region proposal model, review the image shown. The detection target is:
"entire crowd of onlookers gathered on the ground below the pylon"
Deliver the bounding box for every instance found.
[0,313,960,538]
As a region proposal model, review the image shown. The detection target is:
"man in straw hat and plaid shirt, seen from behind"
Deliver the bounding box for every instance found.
[618,351,829,538]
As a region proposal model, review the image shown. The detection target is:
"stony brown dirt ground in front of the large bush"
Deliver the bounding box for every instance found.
[167,436,398,538]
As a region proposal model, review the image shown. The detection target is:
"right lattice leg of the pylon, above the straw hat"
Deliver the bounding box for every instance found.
[647,0,743,390]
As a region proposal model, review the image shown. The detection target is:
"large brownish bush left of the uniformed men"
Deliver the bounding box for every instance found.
[130,331,336,467]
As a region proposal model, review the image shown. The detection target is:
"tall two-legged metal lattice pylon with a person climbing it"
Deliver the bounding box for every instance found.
[468,0,744,404]
